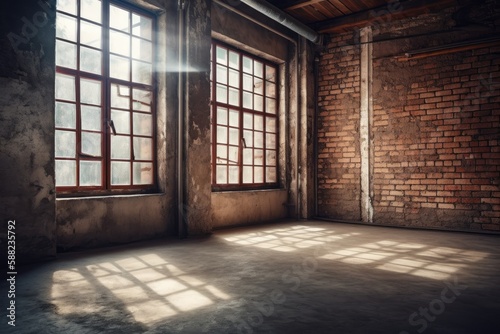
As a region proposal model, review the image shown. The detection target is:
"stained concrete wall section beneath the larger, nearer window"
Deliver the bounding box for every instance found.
[57,194,168,250]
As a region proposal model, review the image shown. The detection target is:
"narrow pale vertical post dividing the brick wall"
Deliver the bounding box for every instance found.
[359,27,373,223]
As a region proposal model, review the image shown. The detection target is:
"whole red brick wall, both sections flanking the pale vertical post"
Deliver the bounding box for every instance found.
[318,10,500,231]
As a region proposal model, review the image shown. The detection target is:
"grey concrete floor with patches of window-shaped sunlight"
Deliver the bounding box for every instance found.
[0,221,500,334]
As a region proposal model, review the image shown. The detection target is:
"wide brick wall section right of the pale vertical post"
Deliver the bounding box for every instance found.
[372,48,500,230]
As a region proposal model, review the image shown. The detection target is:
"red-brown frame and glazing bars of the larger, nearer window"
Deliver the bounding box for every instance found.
[54,0,158,197]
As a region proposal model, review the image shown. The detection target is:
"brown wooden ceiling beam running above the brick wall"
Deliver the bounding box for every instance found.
[311,0,473,33]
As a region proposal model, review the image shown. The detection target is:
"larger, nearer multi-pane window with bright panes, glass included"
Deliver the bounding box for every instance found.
[55,0,155,192]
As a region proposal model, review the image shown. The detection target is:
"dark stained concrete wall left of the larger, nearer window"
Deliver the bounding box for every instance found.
[0,0,56,263]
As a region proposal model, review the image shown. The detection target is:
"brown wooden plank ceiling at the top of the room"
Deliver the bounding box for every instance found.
[267,0,464,32]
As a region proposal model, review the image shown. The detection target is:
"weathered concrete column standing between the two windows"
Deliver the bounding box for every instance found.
[183,0,212,235]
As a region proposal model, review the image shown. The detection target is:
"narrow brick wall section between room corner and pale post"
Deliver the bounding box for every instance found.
[318,34,361,220]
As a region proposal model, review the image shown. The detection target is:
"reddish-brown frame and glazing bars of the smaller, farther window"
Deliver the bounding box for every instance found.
[210,39,281,192]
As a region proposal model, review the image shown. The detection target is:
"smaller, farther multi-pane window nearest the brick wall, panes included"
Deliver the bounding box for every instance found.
[211,41,278,190]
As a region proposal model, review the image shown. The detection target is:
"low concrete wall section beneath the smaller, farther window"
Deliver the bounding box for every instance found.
[212,190,288,228]
